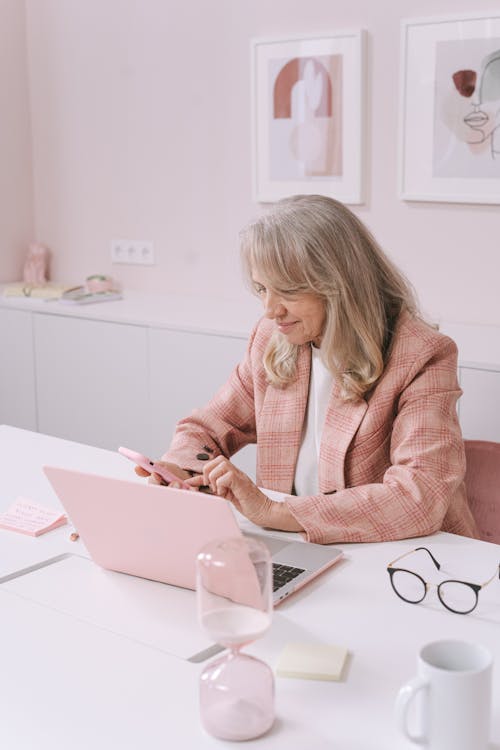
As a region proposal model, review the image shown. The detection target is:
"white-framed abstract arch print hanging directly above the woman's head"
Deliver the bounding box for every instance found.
[252,30,364,203]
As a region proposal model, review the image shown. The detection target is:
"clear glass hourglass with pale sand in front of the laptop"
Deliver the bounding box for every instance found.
[196,537,274,740]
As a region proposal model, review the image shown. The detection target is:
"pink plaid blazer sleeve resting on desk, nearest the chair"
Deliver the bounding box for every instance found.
[286,337,475,544]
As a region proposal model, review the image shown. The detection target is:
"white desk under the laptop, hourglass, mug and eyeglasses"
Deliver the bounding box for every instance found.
[0,426,500,750]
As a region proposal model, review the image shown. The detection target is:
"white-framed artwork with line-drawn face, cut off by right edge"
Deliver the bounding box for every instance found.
[399,11,500,203]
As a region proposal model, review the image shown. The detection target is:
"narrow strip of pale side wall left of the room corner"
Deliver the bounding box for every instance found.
[0,0,33,281]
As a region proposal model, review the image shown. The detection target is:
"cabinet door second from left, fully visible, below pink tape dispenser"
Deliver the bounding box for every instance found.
[35,314,152,453]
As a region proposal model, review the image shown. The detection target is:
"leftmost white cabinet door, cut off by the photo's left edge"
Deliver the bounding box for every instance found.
[0,309,37,430]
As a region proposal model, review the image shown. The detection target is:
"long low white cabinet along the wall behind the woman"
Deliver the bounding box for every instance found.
[0,295,500,470]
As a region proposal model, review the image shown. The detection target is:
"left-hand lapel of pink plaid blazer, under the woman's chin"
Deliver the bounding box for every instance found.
[258,346,311,493]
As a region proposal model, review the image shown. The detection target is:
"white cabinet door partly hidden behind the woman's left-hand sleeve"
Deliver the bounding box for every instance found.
[149,328,256,477]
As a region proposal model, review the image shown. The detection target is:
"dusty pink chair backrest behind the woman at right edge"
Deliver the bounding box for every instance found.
[465,440,500,544]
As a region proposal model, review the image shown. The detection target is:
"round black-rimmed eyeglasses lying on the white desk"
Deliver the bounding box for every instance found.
[387,547,500,615]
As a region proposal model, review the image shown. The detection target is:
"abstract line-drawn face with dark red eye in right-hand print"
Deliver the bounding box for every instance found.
[452,49,500,159]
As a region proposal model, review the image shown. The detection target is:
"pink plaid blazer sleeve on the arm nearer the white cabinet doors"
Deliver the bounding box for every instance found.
[162,326,258,472]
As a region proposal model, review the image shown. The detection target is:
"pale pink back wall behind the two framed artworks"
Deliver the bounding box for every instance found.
[17,0,500,325]
